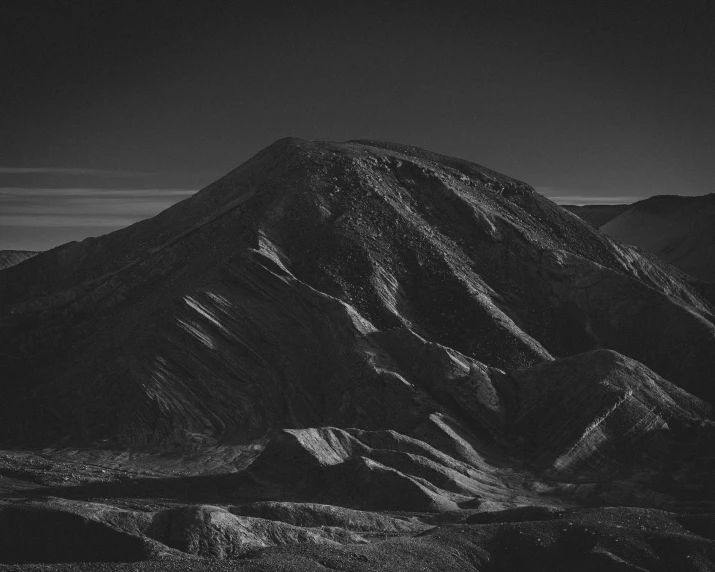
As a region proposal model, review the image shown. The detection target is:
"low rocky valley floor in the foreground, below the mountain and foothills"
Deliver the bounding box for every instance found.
[0,446,715,572]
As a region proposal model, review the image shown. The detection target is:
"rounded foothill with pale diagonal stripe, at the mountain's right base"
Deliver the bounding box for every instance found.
[511,350,711,481]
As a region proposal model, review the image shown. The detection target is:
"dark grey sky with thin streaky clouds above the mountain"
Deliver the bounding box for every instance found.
[0,0,715,249]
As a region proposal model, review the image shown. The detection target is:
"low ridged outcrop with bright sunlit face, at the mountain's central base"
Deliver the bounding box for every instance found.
[248,427,480,512]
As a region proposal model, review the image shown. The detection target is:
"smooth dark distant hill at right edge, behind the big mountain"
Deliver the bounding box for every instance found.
[601,193,715,282]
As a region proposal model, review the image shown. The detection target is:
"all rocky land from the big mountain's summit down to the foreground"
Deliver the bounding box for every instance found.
[0,139,715,570]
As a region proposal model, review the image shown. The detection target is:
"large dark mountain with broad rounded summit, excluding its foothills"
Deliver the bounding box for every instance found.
[0,139,715,445]
